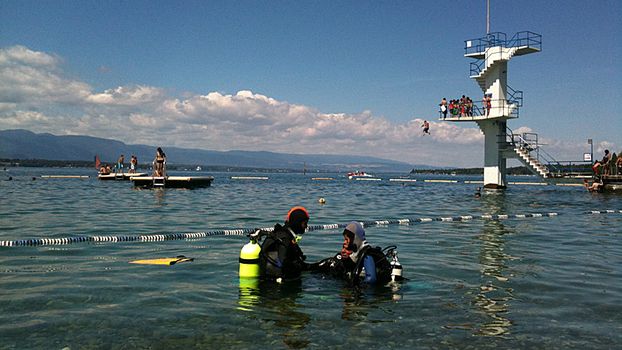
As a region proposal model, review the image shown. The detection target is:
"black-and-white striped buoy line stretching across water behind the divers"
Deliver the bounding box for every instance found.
[0,210,622,247]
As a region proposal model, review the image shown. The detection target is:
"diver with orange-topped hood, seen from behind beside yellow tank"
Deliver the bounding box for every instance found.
[259,207,309,283]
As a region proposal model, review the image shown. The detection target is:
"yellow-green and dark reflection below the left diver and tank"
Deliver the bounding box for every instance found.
[238,278,311,349]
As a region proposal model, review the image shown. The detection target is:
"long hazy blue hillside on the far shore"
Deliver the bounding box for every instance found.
[0,130,432,172]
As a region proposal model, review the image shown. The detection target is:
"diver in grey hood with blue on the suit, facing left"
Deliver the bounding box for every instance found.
[310,221,394,286]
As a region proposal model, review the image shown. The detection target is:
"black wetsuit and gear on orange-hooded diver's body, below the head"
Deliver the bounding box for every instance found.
[259,224,307,281]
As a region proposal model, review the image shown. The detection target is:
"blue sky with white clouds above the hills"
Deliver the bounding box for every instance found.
[0,0,622,167]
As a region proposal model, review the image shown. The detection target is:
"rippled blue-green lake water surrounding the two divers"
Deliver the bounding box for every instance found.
[0,168,622,349]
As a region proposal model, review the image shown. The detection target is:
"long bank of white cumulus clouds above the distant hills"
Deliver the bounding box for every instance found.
[0,46,567,167]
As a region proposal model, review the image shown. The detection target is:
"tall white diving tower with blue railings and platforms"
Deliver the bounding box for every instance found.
[445,31,542,189]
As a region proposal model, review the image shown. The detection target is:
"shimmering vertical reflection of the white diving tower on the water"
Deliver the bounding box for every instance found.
[472,221,514,336]
